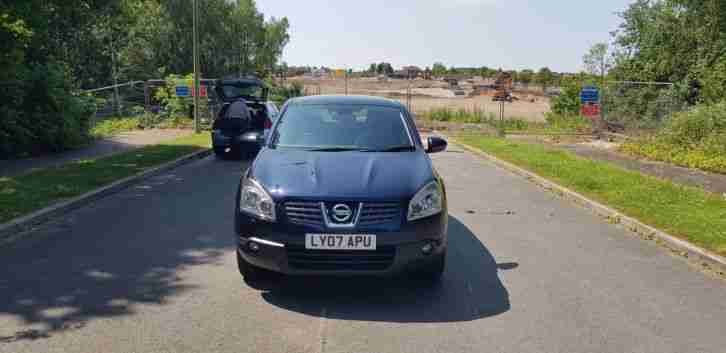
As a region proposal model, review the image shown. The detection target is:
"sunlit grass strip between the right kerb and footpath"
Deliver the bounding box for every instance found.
[457,135,726,255]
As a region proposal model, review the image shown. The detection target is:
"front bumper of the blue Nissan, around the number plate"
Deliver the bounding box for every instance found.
[236,213,447,276]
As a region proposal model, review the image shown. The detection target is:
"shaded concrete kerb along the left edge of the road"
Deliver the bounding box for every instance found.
[0,149,212,246]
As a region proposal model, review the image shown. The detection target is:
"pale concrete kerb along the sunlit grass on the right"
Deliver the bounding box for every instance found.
[446,133,726,275]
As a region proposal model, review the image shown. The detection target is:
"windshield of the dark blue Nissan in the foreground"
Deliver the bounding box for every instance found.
[272,105,413,150]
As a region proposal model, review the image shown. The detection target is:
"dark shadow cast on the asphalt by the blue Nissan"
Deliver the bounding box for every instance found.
[262,216,517,323]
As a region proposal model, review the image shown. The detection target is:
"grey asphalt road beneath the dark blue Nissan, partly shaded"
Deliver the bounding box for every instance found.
[0,147,726,353]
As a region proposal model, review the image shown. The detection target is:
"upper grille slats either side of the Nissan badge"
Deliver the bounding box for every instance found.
[284,201,401,226]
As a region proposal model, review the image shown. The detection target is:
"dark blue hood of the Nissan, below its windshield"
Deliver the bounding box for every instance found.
[249,148,434,200]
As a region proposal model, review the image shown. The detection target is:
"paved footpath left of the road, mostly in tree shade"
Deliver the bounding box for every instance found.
[0,129,192,177]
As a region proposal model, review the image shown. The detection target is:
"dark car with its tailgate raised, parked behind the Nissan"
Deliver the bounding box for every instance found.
[212,78,274,157]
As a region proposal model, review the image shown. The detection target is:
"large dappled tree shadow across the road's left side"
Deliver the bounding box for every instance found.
[0,155,244,345]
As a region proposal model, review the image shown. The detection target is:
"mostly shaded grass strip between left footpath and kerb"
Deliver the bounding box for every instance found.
[0,133,210,223]
